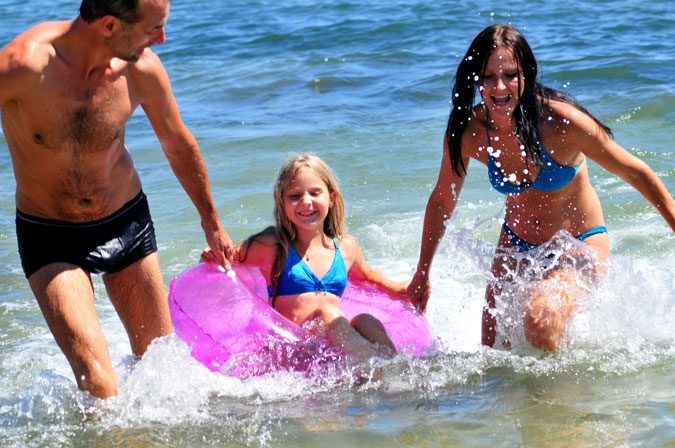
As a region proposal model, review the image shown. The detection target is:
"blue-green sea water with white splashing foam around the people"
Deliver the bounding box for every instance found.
[0,0,675,448]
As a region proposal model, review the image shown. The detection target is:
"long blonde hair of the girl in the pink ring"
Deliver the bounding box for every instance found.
[242,154,345,305]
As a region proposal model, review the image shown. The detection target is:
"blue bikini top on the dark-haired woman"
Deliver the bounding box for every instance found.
[485,124,584,194]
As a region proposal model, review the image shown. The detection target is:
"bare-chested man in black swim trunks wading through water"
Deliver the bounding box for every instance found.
[0,0,232,398]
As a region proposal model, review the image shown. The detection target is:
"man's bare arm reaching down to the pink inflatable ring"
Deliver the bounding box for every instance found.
[134,49,233,269]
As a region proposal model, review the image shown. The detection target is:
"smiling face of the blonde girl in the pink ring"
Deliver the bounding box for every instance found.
[283,168,335,231]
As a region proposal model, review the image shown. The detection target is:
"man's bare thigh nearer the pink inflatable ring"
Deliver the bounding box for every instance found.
[103,252,173,356]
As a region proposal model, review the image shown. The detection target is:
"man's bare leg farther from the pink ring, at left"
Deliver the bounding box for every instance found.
[28,263,119,398]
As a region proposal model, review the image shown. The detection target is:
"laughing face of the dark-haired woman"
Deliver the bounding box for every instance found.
[478,47,524,117]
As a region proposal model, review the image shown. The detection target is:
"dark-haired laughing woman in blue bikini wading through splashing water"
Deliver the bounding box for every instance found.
[408,25,675,350]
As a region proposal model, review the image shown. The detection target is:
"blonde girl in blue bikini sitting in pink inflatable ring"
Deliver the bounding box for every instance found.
[202,155,408,362]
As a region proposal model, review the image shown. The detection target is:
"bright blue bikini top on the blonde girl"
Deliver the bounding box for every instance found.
[277,237,347,297]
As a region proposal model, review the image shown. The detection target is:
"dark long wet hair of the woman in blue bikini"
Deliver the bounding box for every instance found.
[445,24,612,176]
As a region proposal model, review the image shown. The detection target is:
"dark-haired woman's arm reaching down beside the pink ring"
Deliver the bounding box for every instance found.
[408,139,469,313]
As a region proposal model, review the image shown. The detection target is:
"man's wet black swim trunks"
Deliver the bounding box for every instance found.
[16,191,157,278]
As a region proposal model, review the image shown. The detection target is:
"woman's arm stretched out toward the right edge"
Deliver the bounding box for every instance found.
[563,103,675,232]
